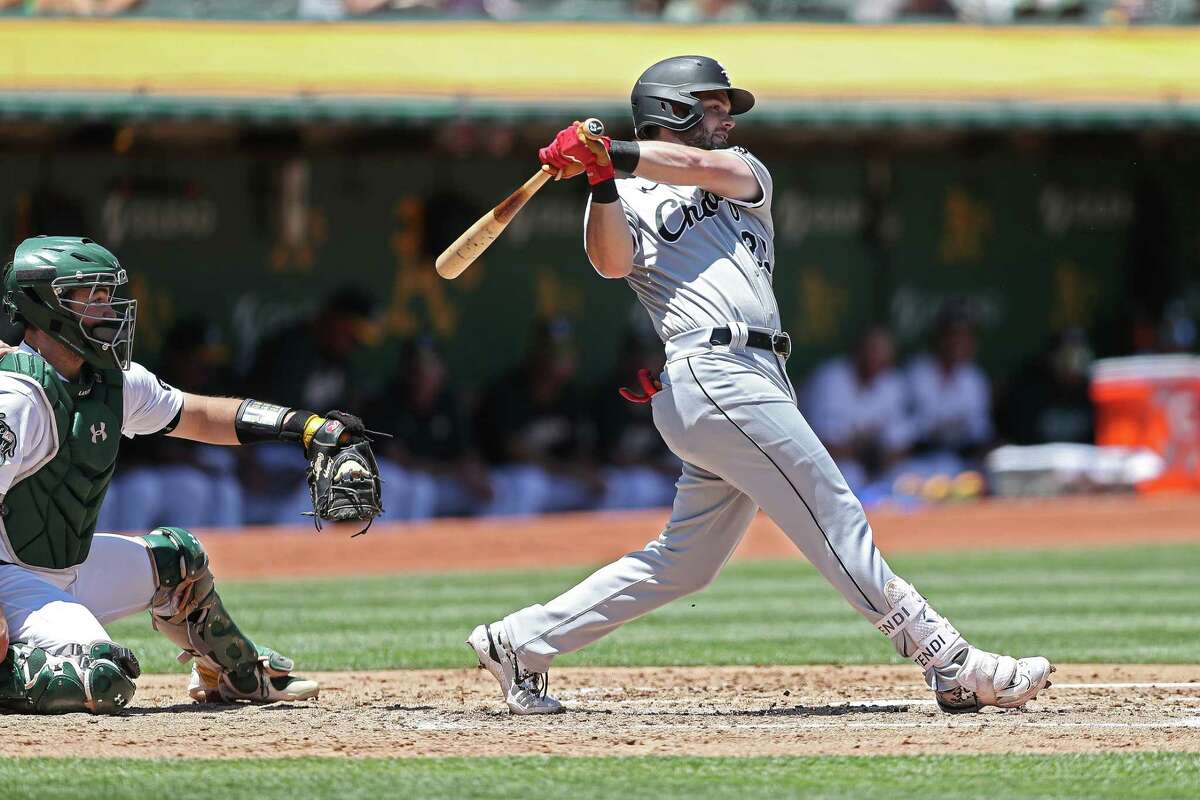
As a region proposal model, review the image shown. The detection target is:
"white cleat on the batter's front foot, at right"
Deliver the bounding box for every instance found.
[934,648,1054,714]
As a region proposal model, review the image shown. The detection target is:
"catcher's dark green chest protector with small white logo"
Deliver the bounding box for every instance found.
[0,353,122,570]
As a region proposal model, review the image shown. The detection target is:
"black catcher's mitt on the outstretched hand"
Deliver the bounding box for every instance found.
[307,411,383,536]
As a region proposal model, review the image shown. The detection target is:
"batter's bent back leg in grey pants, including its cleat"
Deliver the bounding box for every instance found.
[468,463,757,714]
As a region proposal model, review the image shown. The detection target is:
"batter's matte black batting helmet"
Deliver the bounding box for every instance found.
[630,55,754,139]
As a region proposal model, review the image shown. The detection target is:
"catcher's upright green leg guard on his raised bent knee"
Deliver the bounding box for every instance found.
[142,528,260,692]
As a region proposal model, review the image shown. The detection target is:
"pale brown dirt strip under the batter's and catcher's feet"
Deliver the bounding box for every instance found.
[0,664,1200,758]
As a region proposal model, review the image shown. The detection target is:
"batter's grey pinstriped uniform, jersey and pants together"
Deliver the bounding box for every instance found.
[503,148,934,685]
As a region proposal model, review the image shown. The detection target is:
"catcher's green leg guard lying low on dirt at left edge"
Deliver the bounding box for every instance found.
[0,640,142,714]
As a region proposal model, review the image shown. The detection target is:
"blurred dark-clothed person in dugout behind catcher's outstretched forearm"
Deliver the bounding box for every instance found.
[239,285,374,524]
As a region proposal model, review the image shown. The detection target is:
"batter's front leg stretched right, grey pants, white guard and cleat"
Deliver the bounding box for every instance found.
[674,356,1052,710]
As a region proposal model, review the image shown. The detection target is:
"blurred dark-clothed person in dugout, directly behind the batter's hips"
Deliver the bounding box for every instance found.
[592,323,683,510]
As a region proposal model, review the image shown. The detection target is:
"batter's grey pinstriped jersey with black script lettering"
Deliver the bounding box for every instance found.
[584,148,780,342]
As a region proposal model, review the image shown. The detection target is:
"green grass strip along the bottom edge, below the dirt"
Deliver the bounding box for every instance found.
[7,753,1200,800]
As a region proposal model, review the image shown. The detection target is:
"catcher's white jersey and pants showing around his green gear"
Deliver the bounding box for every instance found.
[0,347,184,655]
